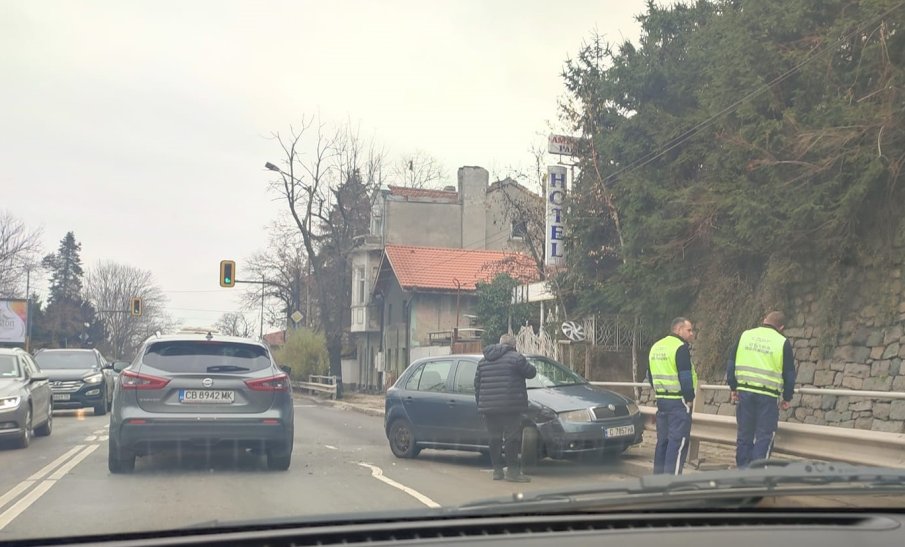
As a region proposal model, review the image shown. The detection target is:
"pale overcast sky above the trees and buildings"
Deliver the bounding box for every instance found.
[0,0,645,332]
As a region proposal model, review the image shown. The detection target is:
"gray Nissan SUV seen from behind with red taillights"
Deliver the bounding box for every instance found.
[108,333,293,473]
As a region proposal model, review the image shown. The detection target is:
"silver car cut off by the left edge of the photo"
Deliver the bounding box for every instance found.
[0,348,53,448]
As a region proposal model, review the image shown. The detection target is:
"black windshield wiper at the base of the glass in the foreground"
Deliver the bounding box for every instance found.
[457,460,905,512]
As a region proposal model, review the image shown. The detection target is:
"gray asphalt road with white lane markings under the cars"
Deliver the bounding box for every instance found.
[0,400,646,540]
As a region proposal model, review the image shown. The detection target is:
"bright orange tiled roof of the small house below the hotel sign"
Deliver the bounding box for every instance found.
[385,245,538,291]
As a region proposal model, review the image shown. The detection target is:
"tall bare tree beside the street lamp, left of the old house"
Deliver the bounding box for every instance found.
[266,118,383,396]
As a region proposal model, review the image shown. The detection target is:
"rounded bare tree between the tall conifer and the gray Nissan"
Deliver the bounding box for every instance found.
[85,261,173,358]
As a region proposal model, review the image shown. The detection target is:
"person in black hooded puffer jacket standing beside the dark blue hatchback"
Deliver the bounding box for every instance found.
[475,334,537,482]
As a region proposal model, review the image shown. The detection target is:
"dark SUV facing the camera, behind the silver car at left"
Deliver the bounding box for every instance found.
[35,349,116,416]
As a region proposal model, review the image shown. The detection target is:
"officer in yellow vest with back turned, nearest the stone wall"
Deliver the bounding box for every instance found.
[726,311,795,469]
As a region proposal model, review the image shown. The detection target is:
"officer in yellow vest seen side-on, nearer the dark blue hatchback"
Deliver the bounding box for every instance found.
[649,317,698,475]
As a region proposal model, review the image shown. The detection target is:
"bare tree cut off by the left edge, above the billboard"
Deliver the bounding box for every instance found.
[0,210,41,297]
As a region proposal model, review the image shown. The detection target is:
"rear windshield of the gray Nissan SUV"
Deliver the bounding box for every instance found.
[142,341,270,372]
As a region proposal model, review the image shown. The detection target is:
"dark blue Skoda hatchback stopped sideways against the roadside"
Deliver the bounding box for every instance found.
[384,355,644,465]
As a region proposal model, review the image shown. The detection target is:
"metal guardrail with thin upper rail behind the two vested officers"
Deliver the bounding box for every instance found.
[591,382,905,467]
